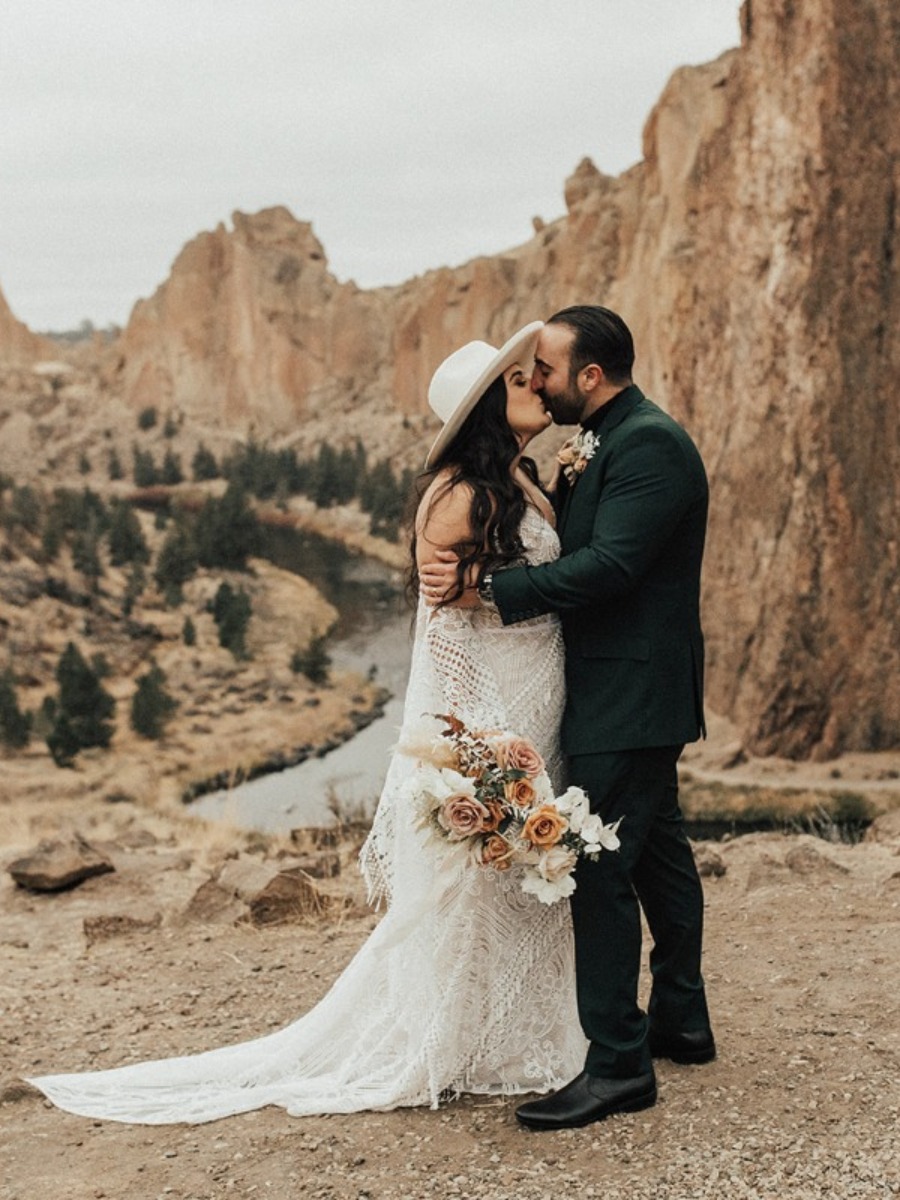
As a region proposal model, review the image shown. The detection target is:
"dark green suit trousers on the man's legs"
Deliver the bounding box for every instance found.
[569,746,709,1079]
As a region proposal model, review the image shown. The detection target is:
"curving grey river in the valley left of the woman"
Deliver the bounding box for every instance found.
[191,528,412,833]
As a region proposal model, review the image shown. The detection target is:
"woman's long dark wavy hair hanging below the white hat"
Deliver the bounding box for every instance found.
[408,376,541,604]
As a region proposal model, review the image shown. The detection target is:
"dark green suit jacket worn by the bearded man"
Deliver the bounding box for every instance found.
[493,385,709,755]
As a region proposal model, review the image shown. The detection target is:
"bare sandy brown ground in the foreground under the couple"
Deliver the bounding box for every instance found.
[0,745,900,1200]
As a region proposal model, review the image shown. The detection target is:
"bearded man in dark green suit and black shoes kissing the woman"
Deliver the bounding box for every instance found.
[422,305,715,1129]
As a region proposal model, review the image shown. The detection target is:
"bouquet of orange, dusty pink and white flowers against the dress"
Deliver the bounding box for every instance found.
[401,714,620,904]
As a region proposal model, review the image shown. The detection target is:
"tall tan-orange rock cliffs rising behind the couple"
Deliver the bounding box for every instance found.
[0,0,900,757]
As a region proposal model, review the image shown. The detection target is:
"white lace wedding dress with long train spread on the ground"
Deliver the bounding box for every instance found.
[30,508,587,1124]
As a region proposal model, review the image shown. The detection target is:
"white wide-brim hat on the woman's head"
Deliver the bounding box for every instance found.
[425,320,544,468]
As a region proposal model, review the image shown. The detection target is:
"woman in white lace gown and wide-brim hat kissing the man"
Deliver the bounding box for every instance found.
[30,322,587,1124]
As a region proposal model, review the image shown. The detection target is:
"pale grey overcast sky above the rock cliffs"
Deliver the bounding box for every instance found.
[0,0,739,330]
